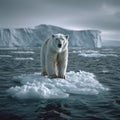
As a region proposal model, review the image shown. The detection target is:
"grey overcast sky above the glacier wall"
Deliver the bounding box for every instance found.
[0,0,120,40]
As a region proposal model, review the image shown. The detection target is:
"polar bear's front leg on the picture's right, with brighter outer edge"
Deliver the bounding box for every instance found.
[58,51,68,79]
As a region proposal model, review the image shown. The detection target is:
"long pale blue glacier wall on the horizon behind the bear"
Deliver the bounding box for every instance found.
[0,25,102,48]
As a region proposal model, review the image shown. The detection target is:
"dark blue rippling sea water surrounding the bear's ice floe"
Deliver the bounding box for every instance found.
[0,48,120,120]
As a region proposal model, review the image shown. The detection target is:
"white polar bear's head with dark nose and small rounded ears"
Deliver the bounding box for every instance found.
[52,33,69,52]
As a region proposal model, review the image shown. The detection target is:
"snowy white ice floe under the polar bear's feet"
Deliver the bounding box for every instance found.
[8,71,108,99]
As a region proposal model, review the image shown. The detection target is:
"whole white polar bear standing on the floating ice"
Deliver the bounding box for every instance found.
[41,33,69,79]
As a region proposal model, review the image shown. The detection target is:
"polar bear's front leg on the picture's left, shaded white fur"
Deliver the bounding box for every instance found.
[46,52,57,78]
